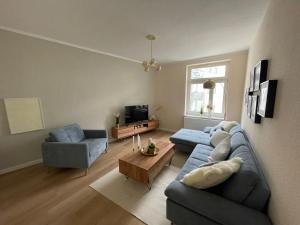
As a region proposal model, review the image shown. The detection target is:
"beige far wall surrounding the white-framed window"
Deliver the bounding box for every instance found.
[155,51,248,130]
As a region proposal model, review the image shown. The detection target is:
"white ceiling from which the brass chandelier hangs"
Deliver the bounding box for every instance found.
[0,0,268,63]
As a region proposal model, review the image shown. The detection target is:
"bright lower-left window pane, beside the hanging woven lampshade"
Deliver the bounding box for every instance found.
[189,84,209,114]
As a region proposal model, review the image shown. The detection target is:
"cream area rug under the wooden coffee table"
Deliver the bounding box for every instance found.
[90,153,186,225]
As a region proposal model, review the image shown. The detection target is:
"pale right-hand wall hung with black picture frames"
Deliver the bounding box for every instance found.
[242,0,300,225]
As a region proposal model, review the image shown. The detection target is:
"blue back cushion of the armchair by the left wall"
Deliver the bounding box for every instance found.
[49,123,84,143]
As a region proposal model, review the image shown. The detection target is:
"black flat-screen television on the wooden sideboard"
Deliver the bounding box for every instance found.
[125,105,148,124]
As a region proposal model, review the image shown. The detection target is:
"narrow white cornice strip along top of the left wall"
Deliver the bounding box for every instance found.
[0,26,142,63]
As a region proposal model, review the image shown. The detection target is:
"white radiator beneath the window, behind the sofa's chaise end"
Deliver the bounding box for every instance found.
[183,116,222,130]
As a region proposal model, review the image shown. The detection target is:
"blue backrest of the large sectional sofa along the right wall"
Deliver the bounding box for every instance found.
[221,127,270,211]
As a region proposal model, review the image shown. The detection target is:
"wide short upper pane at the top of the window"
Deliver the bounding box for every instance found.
[191,65,226,79]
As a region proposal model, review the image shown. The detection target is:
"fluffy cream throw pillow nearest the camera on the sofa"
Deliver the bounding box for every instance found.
[180,157,243,189]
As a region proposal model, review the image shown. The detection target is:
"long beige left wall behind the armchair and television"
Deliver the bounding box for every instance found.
[0,30,154,170]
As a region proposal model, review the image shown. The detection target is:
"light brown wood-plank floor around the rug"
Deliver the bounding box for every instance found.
[0,131,170,225]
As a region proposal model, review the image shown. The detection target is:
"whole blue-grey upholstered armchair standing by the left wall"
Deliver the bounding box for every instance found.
[42,124,108,174]
